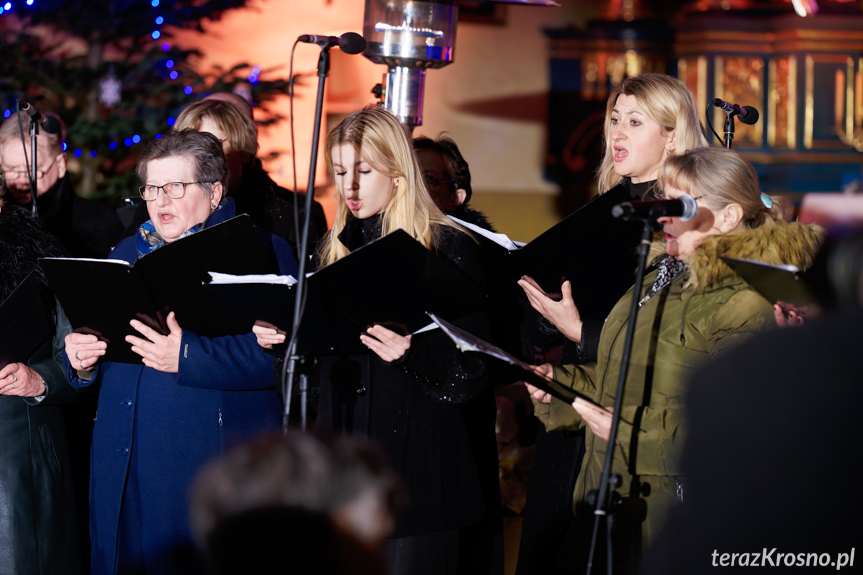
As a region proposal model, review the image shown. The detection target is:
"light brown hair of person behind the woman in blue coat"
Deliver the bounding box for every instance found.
[174,99,258,162]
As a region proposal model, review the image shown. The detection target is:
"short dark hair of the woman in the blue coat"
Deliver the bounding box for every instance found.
[136,129,228,194]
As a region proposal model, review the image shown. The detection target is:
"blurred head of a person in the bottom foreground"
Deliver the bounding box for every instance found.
[190,432,401,575]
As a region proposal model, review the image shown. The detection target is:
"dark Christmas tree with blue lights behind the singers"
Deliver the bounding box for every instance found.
[0,0,298,205]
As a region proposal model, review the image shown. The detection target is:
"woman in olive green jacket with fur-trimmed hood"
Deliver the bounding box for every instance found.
[528,148,820,573]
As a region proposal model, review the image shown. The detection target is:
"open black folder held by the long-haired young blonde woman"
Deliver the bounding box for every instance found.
[207,230,485,355]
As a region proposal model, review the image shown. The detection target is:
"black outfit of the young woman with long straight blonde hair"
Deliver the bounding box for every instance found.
[316,216,500,575]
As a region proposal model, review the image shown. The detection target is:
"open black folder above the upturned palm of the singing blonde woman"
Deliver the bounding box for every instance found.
[453,188,642,319]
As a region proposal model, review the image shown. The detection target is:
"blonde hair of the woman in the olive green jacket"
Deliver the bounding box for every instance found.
[658,148,793,228]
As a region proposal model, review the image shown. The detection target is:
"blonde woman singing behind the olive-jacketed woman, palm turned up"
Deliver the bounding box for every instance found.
[516,73,707,575]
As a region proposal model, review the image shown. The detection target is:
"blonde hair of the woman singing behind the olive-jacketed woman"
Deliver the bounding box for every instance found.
[596,72,708,194]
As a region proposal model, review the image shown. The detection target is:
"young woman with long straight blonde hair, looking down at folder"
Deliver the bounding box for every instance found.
[256,107,500,575]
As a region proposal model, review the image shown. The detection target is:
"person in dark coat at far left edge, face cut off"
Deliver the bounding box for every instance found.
[0,180,81,575]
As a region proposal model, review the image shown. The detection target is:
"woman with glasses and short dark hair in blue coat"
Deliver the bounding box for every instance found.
[64,130,297,574]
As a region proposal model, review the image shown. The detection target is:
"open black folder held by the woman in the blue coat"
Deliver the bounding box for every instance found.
[41,215,278,363]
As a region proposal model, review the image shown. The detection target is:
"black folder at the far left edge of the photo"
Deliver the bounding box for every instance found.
[0,272,51,369]
